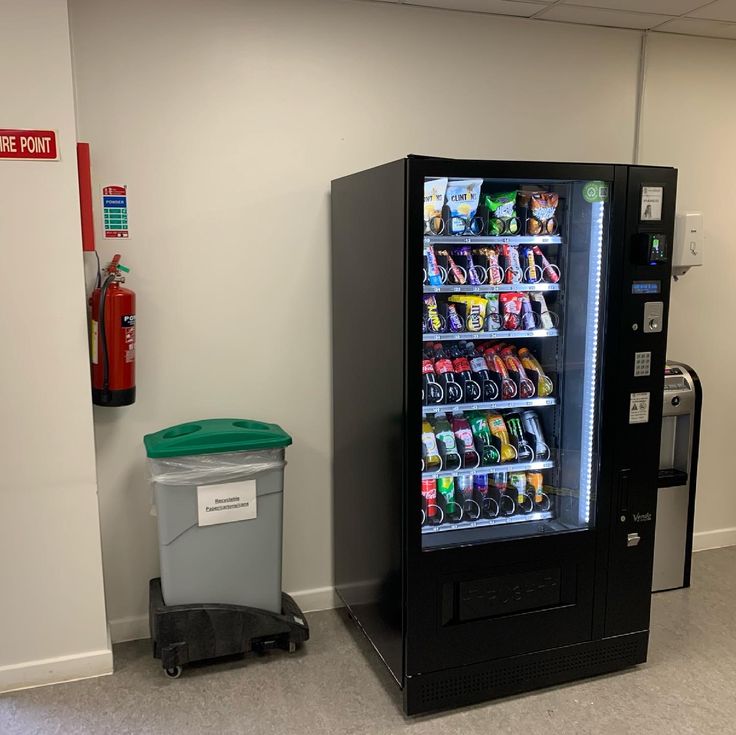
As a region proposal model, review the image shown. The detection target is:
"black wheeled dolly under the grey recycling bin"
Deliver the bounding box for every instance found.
[148,577,309,679]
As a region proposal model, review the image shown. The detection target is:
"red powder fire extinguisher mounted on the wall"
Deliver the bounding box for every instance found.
[90,255,135,406]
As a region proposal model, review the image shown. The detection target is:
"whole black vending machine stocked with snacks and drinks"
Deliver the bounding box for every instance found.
[332,156,677,714]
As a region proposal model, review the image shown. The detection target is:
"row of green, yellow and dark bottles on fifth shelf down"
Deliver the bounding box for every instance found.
[422,410,551,472]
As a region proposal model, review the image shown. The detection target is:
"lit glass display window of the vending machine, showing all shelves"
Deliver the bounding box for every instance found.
[420,176,610,551]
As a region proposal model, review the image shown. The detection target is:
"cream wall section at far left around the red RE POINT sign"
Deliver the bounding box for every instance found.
[0,0,112,691]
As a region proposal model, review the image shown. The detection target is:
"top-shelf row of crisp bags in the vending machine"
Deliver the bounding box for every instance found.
[424,178,560,236]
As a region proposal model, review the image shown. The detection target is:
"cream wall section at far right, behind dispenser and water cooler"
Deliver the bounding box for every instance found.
[641,34,736,548]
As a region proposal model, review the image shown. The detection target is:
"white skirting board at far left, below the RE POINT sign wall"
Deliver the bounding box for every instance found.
[0,648,112,693]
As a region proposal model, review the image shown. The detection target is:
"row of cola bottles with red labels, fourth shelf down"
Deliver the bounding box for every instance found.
[422,342,554,406]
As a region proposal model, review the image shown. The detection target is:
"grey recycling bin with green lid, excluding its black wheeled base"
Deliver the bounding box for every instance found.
[144,419,291,613]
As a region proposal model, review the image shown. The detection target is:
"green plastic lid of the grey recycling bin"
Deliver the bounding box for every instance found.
[143,419,291,458]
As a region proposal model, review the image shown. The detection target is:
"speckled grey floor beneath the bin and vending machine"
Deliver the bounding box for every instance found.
[0,547,736,735]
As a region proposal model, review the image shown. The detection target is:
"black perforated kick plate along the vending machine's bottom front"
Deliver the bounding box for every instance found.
[404,631,649,715]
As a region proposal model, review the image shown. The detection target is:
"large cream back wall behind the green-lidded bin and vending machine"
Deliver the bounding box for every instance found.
[70,0,639,637]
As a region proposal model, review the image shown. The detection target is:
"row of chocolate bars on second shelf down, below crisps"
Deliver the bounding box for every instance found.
[424,242,560,286]
